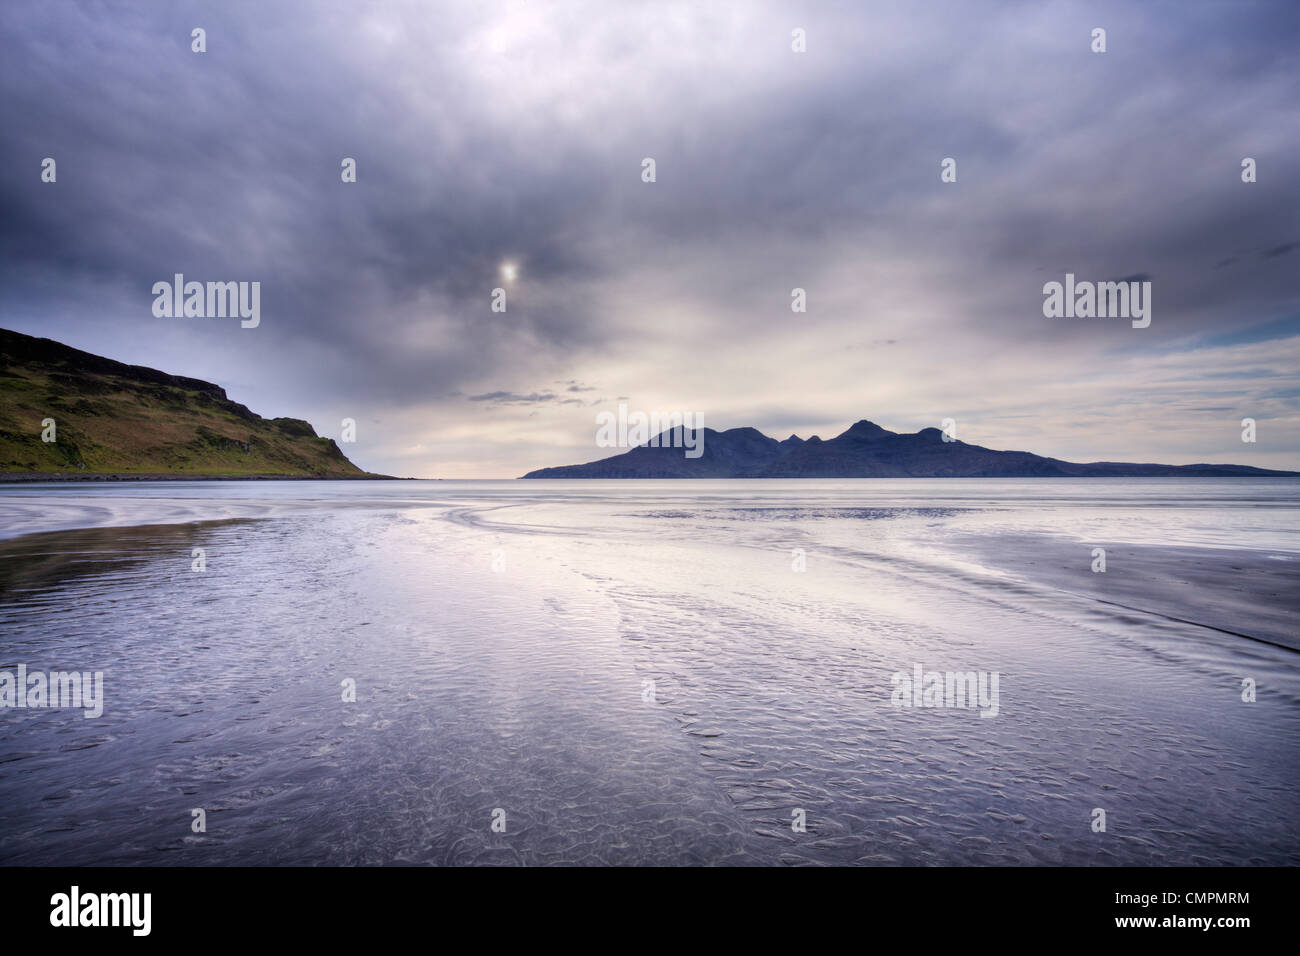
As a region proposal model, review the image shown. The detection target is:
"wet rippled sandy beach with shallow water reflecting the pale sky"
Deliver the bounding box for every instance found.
[0,479,1300,865]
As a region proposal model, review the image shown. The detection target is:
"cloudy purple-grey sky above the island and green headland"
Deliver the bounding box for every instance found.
[0,0,1300,477]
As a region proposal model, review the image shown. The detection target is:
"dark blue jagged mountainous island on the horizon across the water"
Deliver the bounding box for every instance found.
[524,420,1300,479]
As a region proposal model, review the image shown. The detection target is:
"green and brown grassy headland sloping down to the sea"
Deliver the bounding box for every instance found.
[0,329,386,480]
